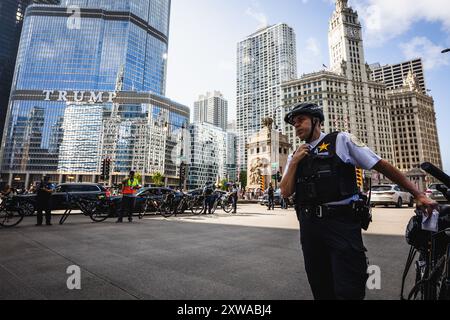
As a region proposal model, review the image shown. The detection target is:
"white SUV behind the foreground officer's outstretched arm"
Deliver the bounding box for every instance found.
[371,185,414,208]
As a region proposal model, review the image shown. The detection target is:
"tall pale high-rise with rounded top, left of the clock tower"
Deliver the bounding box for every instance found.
[237,23,297,171]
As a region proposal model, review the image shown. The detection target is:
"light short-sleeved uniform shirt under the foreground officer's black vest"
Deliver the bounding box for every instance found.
[285,132,381,205]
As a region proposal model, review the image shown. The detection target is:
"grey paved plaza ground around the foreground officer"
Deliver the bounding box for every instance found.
[0,204,413,300]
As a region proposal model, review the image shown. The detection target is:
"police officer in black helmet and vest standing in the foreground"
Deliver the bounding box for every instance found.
[281,104,437,300]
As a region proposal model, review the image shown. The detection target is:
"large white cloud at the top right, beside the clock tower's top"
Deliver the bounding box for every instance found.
[350,0,450,46]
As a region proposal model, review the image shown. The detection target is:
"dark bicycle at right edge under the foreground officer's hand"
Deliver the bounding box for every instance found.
[401,163,450,300]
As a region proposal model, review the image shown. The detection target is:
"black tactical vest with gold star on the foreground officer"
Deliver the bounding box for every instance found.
[295,132,359,206]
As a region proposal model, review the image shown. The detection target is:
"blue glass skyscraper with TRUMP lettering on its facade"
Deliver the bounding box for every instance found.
[1,0,190,188]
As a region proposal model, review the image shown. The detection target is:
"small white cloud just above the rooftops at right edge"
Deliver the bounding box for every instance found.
[400,37,450,70]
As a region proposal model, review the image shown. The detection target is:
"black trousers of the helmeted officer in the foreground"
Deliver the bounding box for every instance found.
[297,210,368,300]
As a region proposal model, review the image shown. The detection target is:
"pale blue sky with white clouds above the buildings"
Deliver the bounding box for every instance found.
[166,0,450,173]
